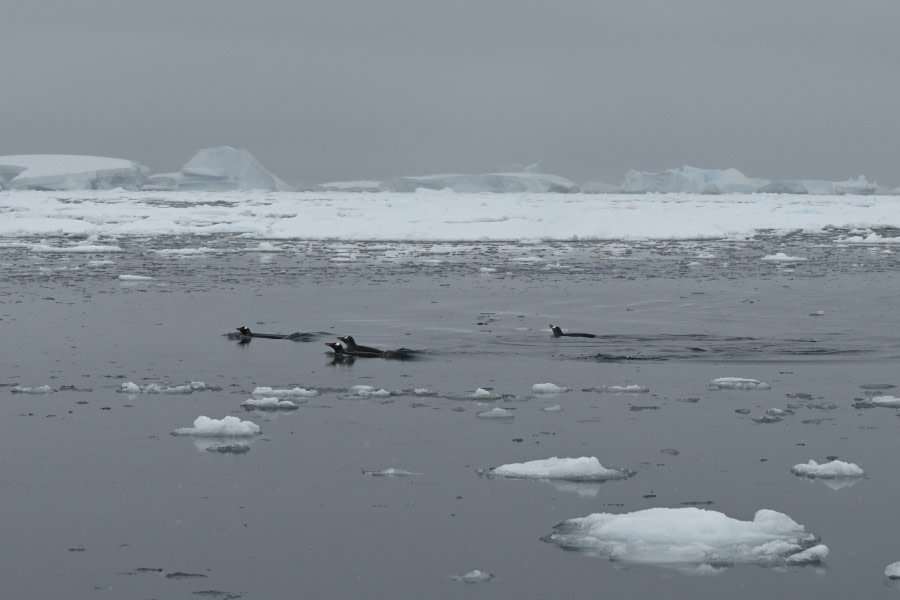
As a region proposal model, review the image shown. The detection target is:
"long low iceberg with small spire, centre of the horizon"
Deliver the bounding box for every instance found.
[384,172,581,194]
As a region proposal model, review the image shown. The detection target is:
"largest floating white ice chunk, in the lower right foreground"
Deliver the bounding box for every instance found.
[544,507,828,566]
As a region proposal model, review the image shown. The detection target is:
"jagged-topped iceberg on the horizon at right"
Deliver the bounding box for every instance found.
[622,167,770,194]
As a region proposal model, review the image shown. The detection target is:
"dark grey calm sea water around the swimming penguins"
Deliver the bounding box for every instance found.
[0,236,900,599]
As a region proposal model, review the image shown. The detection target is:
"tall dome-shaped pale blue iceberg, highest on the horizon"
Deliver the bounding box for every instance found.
[144,146,293,192]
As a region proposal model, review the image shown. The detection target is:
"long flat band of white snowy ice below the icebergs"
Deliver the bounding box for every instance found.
[0,190,900,241]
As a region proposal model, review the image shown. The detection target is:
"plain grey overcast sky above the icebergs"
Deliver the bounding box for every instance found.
[0,0,900,187]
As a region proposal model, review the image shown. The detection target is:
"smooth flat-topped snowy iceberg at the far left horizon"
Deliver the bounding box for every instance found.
[0,154,150,191]
